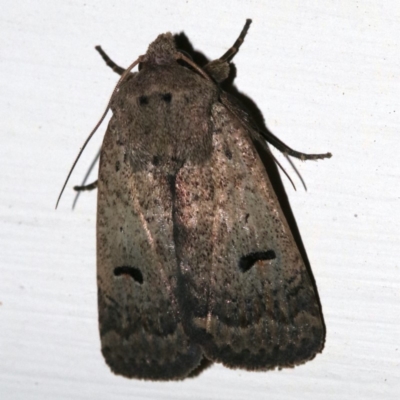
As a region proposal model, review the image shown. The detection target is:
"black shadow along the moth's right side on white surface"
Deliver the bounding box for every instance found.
[174,32,326,338]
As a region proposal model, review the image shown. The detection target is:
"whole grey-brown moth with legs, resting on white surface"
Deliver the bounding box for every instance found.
[57,20,331,380]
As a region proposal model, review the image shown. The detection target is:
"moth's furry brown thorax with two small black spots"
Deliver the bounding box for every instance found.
[126,65,218,170]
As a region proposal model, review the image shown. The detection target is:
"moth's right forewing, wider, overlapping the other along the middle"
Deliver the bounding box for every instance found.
[174,104,324,369]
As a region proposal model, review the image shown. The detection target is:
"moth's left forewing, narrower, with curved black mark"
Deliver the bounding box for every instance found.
[97,118,202,380]
